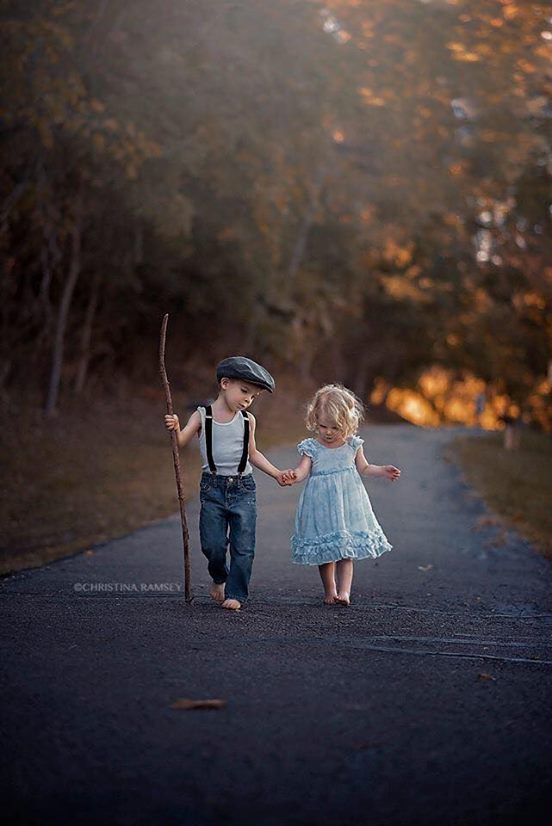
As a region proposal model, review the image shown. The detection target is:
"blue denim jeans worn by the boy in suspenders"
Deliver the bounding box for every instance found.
[199,473,257,602]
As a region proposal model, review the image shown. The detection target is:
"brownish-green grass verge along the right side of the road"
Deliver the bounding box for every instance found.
[451,431,552,559]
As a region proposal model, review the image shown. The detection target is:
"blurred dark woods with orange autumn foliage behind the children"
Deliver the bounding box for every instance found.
[0,0,552,426]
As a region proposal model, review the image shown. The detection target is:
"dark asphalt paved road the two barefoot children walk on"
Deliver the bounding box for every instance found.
[0,425,552,826]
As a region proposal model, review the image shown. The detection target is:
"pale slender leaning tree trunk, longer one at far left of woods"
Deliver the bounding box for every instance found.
[44,193,83,417]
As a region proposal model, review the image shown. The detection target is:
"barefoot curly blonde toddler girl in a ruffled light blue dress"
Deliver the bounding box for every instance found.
[286,384,401,605]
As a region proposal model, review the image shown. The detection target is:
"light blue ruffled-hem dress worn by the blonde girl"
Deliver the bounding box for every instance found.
[291,436,392,565]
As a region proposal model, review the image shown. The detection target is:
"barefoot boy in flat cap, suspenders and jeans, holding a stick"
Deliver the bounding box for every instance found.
[165,356,290,611]
